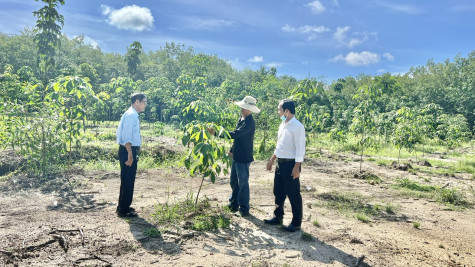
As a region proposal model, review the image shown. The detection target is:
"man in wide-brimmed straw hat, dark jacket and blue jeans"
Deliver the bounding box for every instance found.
[209,96,261,216]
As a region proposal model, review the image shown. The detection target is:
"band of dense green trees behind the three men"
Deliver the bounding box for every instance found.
[0,1,475,177]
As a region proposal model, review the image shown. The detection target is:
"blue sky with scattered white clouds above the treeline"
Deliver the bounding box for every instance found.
[0,0,475,82]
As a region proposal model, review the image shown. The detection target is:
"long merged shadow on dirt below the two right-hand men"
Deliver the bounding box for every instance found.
[208,215,370,267]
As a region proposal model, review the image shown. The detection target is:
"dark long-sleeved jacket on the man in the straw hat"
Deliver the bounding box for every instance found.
[229,115,256,163]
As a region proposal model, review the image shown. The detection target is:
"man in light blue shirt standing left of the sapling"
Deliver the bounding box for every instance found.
[117,93,147,217]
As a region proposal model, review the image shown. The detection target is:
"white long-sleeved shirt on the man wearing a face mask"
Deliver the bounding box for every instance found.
[274,117,305,162]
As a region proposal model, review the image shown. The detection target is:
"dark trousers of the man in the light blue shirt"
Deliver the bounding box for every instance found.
[117,145,140,213]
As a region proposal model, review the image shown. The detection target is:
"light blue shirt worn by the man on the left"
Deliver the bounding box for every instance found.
[117,107,142,146]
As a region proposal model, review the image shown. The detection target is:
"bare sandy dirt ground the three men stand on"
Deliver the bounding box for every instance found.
[0,146,475,266]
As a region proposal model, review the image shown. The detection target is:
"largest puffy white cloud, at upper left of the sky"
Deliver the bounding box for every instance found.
[101,5,154,32]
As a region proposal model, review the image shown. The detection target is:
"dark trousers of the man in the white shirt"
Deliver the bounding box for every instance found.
[274,161,303,227]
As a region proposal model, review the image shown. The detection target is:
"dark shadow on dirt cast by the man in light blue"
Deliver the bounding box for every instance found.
[126,216,181,255]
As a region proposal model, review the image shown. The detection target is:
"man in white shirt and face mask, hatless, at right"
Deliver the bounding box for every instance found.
[264,99,305,232]
